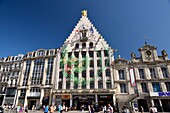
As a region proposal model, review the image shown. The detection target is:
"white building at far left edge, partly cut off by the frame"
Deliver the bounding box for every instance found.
[0,54,24,106]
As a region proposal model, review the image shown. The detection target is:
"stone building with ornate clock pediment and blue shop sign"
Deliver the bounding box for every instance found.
[112,44,170,112]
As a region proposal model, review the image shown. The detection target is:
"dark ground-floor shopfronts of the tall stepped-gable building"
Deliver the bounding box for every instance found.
[52,93,115,110]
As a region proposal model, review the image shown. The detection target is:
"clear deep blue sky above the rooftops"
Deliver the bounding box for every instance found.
[0,0,170,59]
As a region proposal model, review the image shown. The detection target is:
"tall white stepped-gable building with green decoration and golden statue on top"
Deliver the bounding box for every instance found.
[52,10,115,109]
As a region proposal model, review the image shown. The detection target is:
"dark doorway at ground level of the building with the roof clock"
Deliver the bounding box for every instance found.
[137,99,149,112]
